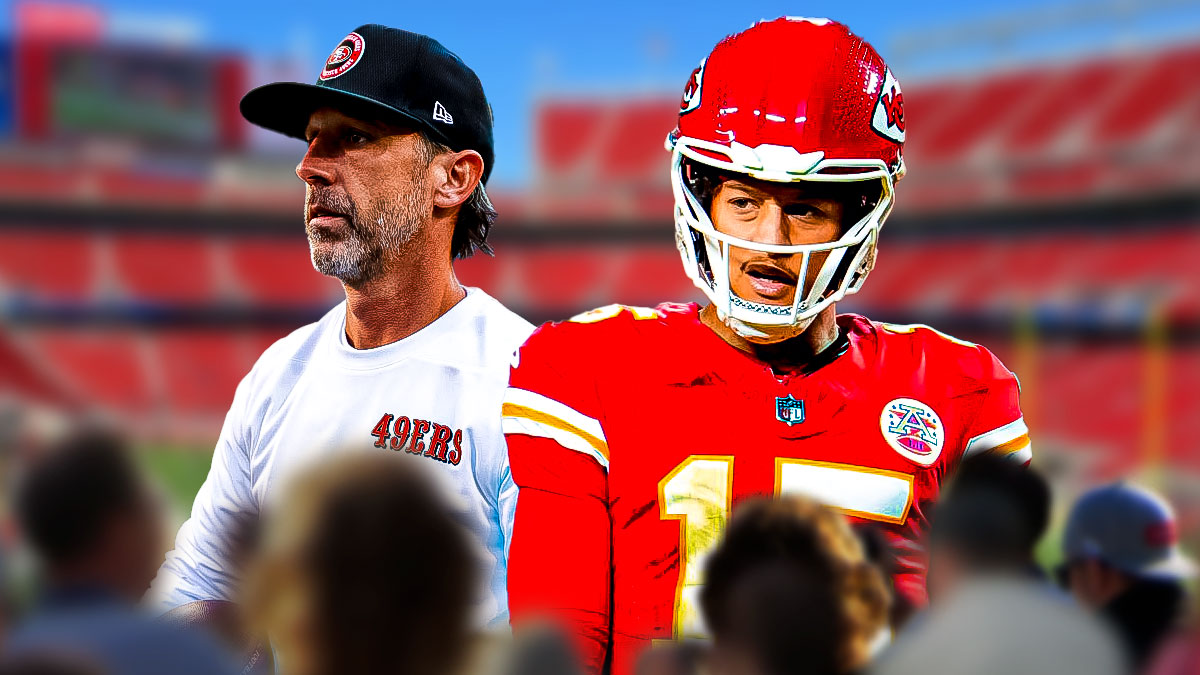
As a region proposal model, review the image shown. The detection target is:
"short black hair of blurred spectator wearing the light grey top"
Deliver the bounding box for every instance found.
[929,455,1050,572]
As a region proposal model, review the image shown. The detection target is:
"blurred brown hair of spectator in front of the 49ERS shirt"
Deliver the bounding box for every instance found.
[268,454,479,675]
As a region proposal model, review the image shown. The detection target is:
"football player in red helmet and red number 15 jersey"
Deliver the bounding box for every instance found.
[504,18,1031,675]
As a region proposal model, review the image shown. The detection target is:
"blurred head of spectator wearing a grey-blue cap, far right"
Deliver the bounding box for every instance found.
[1060,482,1195,667]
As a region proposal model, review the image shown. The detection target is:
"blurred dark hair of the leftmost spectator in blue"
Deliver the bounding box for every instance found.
[14,430,145,565]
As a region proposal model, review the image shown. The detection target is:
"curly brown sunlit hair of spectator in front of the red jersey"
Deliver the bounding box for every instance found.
[701,496,890,675]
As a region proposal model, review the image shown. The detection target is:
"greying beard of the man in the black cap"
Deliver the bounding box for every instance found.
[305,189,431,288]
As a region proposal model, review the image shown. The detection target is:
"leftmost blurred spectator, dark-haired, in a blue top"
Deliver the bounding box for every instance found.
[6,431,236,675]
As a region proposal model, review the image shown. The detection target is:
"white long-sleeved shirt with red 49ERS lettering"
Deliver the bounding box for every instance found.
[150,288,533,625]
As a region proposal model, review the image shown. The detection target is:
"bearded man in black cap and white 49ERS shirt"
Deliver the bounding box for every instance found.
[151,24,533,625]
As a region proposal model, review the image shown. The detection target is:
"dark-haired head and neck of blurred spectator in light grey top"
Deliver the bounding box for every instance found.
[926,455,1050,603]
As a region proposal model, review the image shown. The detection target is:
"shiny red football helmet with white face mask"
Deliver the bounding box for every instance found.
[667,17,905,342]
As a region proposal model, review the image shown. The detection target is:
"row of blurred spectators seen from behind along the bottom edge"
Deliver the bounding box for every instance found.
[0,429,1200,675]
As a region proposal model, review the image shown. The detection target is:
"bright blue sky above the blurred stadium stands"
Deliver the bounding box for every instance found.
[0,0,1200,185]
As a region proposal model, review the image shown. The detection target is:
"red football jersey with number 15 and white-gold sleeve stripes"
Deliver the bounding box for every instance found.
[504,304,1031,675]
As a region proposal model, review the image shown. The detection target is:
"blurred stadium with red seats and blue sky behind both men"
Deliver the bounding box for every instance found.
[0,0,1200,566]
